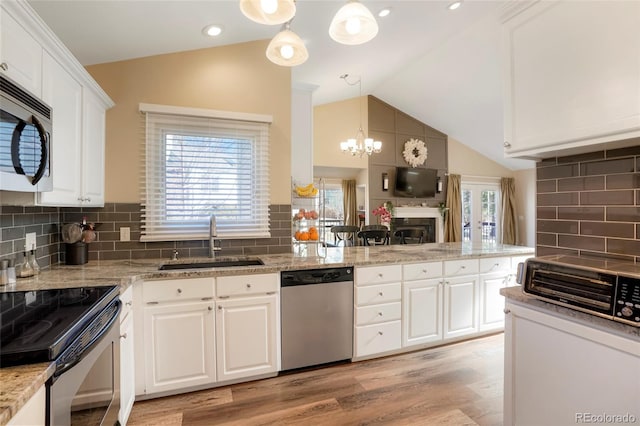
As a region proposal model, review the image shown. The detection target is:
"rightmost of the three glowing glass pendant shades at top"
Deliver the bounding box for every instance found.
[329,0,378,45]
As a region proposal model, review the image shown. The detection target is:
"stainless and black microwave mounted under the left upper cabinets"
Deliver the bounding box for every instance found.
[0,75,53,192]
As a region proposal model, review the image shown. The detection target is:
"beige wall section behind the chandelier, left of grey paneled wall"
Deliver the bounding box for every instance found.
[313,96,368,169]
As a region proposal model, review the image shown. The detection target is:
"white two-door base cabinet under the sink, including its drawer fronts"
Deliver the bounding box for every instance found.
[134,274,280,396]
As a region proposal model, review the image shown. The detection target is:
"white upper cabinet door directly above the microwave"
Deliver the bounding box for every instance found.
[0,9,42,98]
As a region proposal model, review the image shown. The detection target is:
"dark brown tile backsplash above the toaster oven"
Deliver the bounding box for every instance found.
[536,145,640,262]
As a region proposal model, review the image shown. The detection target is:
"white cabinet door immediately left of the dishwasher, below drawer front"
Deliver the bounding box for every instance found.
[216,294,279,381]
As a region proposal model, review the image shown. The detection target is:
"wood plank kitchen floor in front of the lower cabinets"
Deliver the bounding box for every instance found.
[128,333,504,426]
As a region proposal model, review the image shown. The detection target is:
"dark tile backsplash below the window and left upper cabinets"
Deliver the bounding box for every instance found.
[0,203,291,267]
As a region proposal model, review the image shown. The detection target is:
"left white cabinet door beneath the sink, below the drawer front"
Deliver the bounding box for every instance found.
[144,300,216,393]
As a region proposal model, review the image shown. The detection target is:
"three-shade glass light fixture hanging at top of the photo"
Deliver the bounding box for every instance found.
[240,0,378,67]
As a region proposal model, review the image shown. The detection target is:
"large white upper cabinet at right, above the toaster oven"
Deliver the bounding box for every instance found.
[503,1,640,158]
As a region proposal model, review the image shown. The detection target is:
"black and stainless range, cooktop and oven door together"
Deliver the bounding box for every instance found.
[0,286,120,426]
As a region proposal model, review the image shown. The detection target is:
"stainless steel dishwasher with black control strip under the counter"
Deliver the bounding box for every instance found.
[280,268,353,370]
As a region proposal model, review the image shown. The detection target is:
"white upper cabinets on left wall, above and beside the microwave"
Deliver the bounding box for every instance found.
[0,1,114,207]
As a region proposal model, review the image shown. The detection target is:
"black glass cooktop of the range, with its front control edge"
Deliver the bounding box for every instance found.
[0,285,119,367]
